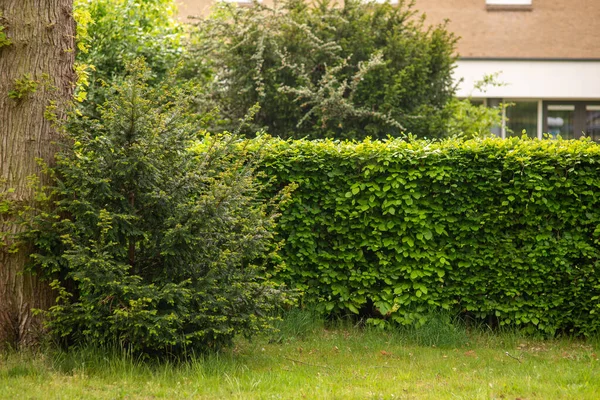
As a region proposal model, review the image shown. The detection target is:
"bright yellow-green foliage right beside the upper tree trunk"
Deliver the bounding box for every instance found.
[75,0,184,112]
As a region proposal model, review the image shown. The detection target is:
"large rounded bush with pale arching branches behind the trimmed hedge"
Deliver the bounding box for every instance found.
[193,0,456,138]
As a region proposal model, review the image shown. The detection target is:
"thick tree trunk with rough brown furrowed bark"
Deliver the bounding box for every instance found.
[0,0,75,347]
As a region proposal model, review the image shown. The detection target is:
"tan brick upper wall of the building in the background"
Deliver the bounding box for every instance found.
[176,0,600,59]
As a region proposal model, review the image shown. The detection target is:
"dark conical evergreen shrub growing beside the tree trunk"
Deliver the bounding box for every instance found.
[28,60,286,355]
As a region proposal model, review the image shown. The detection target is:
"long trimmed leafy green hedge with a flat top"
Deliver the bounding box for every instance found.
[262,138,600,335]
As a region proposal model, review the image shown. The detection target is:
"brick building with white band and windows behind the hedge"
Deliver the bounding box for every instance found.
[178,0,600,140]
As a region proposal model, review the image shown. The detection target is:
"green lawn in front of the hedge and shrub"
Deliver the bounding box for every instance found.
[0,312,600,400]
